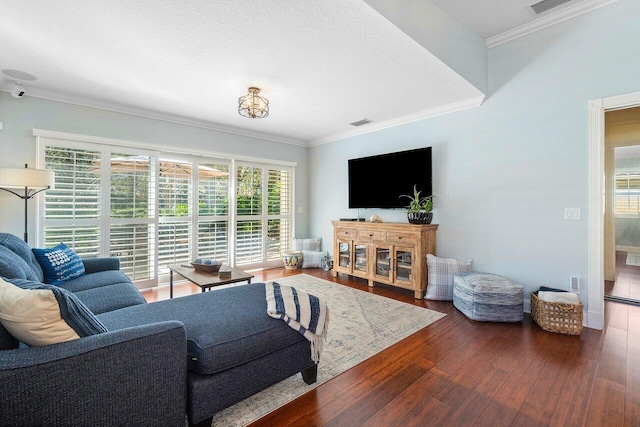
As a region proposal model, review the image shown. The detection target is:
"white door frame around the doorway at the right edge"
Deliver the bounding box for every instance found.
[586,92,640,329]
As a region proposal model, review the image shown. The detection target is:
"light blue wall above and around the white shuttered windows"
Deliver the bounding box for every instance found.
[0,92,309,242]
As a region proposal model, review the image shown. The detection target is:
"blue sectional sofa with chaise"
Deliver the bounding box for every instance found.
[0,233,317,426]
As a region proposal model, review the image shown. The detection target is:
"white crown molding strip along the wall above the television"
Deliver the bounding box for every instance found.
[309,95,485,147]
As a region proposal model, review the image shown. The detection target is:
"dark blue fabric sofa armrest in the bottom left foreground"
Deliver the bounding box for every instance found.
[0,321,187,427]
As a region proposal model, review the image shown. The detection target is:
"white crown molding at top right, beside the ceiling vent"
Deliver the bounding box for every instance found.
[486,0,617,49]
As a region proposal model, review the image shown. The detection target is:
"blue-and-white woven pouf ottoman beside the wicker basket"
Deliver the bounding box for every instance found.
[453,273,524,322]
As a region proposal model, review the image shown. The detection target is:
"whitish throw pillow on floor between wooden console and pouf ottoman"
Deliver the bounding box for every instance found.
[424,254,472,301]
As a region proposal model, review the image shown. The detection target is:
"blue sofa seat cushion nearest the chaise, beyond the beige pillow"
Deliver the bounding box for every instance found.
[74,282,147,314]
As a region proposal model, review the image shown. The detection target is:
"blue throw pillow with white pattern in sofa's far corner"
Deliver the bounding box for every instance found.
[32,243,85,285]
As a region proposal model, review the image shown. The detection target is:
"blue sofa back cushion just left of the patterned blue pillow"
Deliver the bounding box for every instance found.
[0,233,44,282]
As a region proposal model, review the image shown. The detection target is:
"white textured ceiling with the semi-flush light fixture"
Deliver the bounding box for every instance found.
[0,0,613,145]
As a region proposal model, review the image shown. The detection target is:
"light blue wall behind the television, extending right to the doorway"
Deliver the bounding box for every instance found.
[309,0,640,305]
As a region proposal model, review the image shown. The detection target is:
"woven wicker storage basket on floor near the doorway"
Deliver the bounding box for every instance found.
[531,292,582,335]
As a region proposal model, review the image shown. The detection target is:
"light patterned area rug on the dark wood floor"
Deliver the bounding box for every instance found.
[213,274,445,426]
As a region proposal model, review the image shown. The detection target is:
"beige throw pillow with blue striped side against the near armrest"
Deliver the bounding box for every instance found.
[0,279,107,346]
